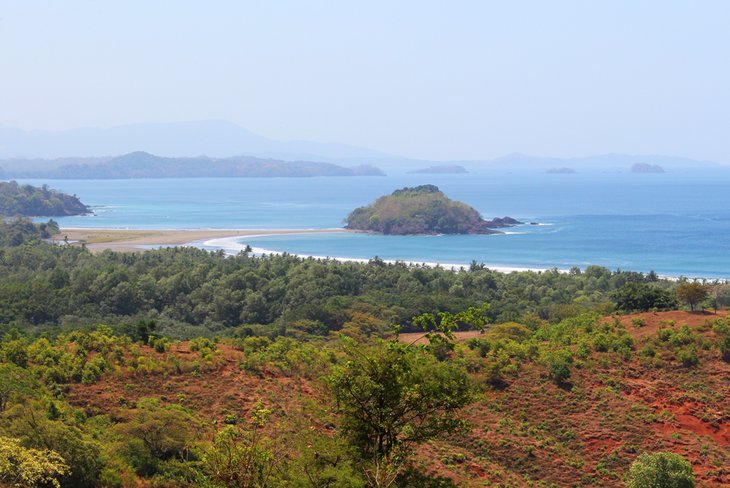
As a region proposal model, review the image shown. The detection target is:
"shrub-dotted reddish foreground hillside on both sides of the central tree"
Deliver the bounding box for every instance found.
[0,311,730,487]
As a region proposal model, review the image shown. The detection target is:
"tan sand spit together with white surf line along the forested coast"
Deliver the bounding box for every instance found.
[57,227,730,283]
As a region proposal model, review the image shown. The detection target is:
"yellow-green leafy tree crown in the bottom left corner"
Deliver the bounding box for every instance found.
[0,437,68,488]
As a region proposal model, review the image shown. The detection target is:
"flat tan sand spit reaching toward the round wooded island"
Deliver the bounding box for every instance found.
[53,228,347,252]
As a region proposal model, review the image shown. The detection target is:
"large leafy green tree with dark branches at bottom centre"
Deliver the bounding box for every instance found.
[327,341,471,486]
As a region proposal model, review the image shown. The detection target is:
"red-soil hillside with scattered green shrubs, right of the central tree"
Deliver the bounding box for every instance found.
[405,311,730,486]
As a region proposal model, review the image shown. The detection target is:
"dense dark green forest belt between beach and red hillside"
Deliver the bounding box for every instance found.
[0,224,676,338]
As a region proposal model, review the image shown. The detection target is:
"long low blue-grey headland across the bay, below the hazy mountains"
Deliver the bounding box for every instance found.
[0,151,384,180]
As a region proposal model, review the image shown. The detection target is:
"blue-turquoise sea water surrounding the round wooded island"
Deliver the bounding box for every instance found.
[19,169,730,278]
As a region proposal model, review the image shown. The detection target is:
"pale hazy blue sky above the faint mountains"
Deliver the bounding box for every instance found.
[0,0,730,162]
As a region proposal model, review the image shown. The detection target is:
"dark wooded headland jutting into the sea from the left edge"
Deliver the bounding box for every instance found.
[0,181,91,217]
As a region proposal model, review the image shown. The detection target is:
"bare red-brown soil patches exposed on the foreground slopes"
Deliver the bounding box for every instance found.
[68,312,730,486]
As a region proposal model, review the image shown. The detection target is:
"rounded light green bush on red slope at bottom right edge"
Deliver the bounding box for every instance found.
[626,452,695,488]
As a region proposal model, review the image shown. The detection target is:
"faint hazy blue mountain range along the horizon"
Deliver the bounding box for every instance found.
[0,121,718,173]
